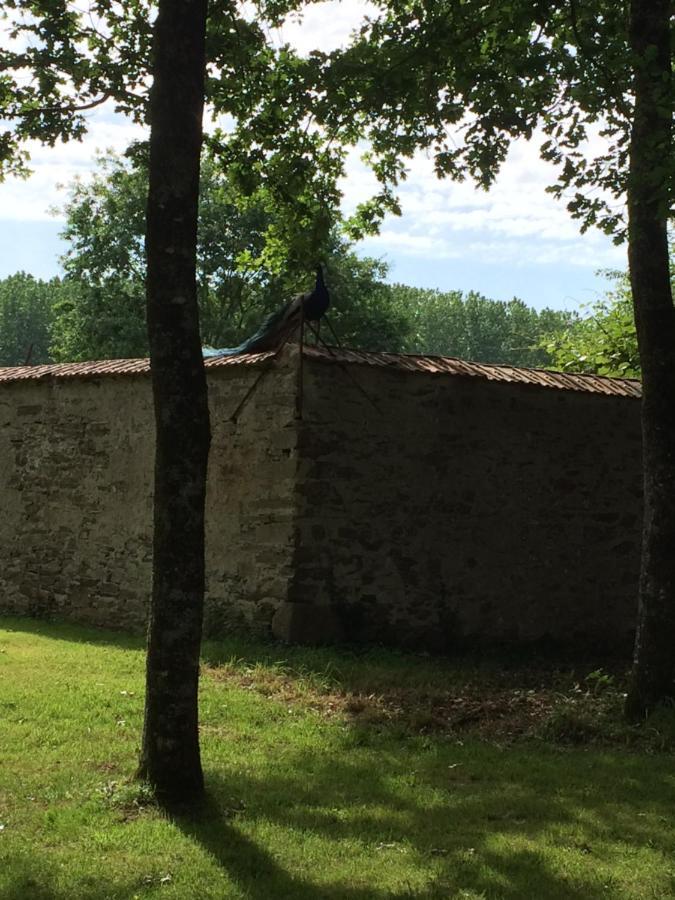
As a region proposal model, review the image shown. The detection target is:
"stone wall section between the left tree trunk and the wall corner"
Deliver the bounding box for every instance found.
[205,347,297,634]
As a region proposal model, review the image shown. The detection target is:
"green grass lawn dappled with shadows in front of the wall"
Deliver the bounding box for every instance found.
[0,619,675,900]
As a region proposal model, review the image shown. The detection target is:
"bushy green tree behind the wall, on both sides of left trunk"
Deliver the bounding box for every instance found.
[53,146,276,360]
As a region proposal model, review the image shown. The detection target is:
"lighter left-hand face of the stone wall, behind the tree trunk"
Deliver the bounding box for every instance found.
[0,352,296,630]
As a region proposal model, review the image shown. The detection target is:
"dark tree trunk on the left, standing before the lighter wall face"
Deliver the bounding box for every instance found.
[139,0,210,803]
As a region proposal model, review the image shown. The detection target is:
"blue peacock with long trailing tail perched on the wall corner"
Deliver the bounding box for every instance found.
[203,266,330,359]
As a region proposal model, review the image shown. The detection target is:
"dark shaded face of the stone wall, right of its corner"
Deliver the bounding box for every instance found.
[291,360,641,650]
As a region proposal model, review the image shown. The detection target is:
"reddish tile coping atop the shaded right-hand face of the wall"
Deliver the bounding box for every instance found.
[305,347,642,397]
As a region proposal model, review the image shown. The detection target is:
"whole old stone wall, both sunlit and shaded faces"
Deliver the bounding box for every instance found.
[0,348,641,650]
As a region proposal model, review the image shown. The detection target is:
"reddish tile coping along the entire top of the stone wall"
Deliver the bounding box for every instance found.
[0,346,641,397]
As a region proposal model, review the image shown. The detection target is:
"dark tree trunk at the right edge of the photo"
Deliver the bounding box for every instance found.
[626,0,675,721]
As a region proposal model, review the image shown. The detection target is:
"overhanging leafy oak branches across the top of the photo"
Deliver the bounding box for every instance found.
[0,0,675,268]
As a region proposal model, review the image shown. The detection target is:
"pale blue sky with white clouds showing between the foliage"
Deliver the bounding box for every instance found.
[0,0,626,309]
